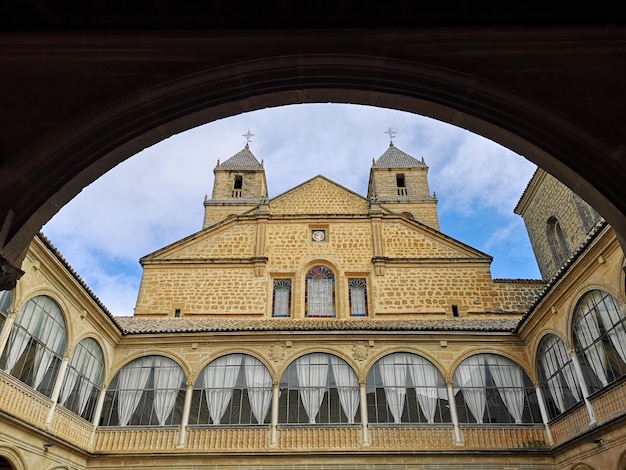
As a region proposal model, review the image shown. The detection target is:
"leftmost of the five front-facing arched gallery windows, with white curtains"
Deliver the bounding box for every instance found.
[101,356,185,426]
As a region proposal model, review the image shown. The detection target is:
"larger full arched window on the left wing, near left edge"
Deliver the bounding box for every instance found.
[0,295,66,396]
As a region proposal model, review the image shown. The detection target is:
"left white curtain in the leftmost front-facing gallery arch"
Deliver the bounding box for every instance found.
[117,356,154,426]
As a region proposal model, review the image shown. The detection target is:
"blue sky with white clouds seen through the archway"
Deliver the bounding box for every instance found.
[42,104,540,316]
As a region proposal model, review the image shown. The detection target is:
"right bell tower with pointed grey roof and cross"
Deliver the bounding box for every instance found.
[367,135,440,230]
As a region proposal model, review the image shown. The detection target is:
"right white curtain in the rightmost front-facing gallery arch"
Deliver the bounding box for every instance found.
[486,354,524,424]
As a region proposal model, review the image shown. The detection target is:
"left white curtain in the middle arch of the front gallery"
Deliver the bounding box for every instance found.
[296,353,328,424]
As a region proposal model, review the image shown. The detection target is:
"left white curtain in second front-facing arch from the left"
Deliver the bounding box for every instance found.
[203,354,243,424]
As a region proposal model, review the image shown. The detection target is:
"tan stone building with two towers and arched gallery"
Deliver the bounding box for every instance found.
[0,144,626,470]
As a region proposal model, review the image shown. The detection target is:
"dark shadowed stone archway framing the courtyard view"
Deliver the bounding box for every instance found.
[0,54,626,284]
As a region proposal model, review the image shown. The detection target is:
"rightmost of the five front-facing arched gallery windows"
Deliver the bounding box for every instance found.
[453,354,542,424]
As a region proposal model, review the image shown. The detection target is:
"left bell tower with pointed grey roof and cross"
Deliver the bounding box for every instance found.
[202,139,267,229]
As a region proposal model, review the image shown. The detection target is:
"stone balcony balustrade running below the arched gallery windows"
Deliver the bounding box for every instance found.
[0,371,626,455]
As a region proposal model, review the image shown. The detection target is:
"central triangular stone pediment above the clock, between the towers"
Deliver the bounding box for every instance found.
[270,176,369,215]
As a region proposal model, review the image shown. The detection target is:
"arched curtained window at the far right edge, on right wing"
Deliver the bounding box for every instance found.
[573,290,626,393]
